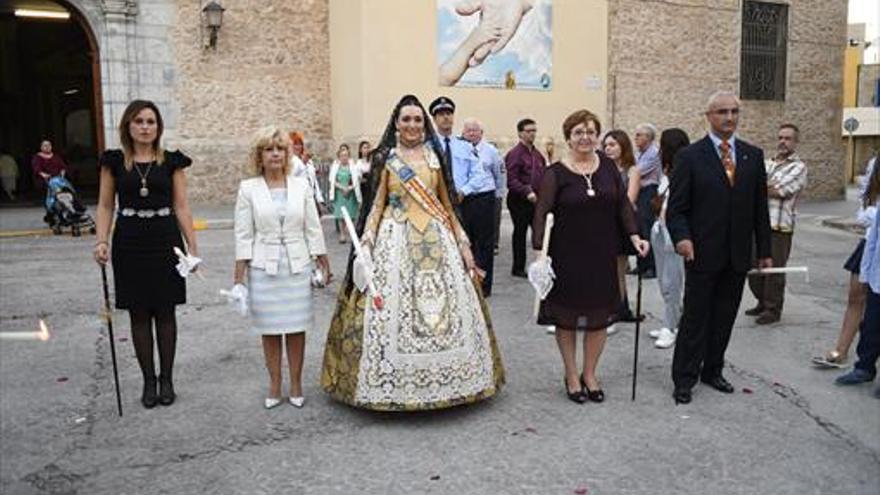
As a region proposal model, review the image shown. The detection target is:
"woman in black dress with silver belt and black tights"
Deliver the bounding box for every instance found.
[94,100,198,409]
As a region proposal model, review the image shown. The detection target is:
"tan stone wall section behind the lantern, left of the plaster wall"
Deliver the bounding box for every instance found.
[170,0,331,203]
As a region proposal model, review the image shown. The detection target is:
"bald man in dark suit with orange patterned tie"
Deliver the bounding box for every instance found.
[666,92,773,404]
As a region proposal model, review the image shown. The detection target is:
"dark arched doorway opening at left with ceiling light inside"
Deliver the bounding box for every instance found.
[0,0,103,205]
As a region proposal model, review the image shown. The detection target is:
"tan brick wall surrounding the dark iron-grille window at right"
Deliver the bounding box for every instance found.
[608,0,847,202]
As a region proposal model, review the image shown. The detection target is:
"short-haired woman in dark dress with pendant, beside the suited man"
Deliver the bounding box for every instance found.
[532,110,648,403]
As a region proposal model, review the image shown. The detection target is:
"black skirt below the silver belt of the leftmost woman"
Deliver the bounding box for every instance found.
[111,215,186,309]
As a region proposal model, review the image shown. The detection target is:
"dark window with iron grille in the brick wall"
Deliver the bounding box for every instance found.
[739,0,788,101]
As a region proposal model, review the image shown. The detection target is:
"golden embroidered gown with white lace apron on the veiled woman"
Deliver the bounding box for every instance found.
[321,147,504,410]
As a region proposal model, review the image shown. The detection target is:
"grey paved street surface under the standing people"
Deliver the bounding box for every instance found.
[0,208,880,495]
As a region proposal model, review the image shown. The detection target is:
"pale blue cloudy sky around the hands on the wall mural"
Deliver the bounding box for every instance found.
[437,0,553,88]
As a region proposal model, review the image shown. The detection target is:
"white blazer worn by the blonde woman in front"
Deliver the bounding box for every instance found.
[235,176,327,275]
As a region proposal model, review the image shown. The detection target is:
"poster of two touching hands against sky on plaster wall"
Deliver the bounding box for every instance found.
[437,0,553,91]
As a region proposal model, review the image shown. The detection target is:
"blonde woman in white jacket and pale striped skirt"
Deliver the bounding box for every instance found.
[234,127,330,409]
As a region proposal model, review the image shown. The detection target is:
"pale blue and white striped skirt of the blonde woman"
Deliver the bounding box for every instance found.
[248,255,313,335]
